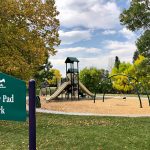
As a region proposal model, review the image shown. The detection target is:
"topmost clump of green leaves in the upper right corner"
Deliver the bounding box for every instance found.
[120,0,150,31]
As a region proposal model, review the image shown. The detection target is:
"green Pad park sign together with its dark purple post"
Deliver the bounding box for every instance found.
[0,72,36,150]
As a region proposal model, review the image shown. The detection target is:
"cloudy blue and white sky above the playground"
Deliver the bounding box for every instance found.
[50,0,138,76]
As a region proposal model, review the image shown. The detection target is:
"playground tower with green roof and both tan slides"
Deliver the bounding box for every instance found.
[46,57,94,101]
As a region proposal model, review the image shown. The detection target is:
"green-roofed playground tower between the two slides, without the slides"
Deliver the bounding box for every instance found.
[65,57,79,99]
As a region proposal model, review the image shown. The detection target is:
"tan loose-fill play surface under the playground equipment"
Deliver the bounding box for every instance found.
[41,97,150,115]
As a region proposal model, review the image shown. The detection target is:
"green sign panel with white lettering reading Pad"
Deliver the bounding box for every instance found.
[0,72,26,121]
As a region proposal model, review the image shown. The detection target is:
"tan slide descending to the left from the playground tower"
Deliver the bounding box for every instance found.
[46,81,71,101]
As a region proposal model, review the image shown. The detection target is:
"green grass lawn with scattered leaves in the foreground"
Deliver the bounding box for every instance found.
[0,113,150,150]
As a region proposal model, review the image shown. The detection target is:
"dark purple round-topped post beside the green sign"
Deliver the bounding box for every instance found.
[29,80,36,150]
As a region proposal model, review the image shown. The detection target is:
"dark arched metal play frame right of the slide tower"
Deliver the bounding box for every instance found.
[94,74,150,108]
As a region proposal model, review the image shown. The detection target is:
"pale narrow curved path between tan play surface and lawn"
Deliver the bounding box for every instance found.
[36,108,150,117]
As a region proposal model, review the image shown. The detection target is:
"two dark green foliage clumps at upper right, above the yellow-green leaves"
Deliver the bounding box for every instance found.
[120,0,150,58]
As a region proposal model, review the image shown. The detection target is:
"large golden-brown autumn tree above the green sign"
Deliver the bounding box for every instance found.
[0,0,60,81]
